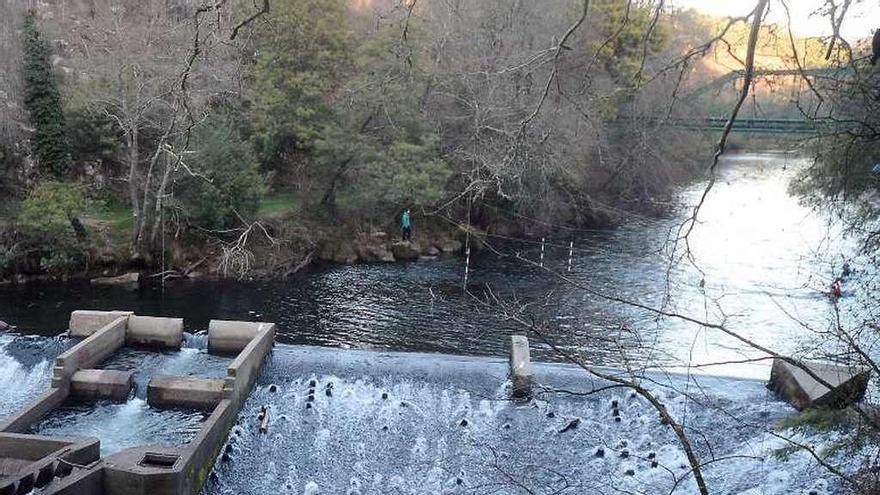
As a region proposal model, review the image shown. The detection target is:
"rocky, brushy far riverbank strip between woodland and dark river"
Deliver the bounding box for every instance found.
[0,189,644,286]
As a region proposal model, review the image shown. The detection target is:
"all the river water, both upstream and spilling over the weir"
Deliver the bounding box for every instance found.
[0,154,860,495]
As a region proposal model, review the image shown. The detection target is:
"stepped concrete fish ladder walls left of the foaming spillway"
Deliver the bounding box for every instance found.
[0,311,275,495]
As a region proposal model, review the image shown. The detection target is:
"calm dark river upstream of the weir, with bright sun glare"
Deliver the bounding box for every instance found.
[0,153,844,378]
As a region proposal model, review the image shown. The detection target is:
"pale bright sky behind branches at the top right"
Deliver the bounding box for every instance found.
[668,0,880,41]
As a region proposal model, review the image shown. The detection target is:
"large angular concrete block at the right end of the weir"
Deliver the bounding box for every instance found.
[767,358,870,411]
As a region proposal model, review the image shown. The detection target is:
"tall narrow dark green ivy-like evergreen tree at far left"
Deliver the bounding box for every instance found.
[22,12,69,177]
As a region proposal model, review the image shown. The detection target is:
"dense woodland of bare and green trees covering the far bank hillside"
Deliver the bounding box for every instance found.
[0,0,868,278]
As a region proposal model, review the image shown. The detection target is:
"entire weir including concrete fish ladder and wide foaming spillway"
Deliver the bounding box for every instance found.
[0,313,868,495]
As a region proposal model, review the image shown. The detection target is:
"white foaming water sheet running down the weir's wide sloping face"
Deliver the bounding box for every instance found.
[204,345,834,495]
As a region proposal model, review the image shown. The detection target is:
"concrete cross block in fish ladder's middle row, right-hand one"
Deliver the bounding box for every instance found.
[147,375,223,411]
